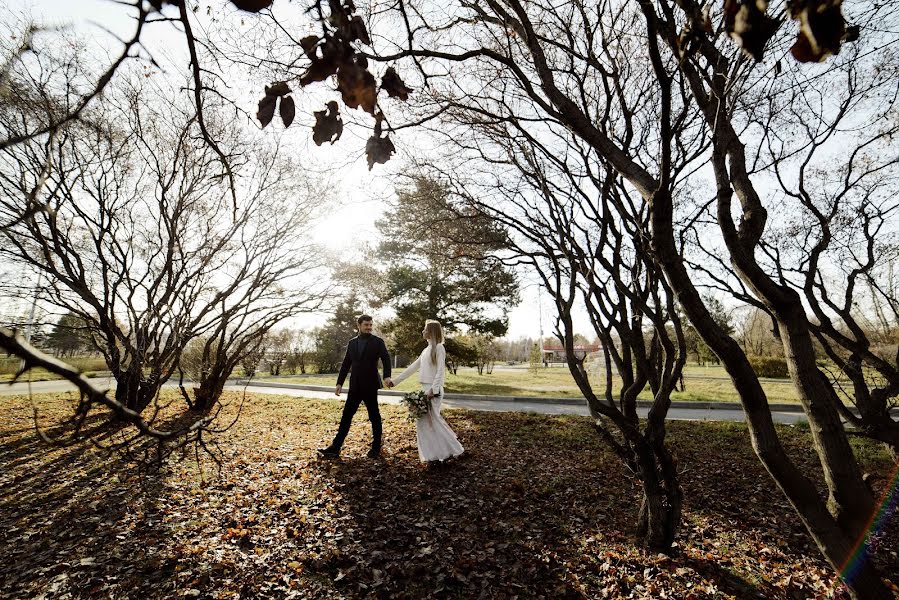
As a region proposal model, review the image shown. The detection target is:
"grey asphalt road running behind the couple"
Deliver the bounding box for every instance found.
[0,377,805,423]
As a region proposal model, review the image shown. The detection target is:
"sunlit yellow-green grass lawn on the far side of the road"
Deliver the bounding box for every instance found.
[274,367,799,403]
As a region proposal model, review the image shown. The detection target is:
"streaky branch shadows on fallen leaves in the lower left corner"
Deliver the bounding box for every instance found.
[0,404,200,597]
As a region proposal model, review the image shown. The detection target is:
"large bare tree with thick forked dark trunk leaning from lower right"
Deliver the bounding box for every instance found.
[340,0,895,598]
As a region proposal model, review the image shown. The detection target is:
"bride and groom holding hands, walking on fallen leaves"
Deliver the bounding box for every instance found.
[318,315,464,463]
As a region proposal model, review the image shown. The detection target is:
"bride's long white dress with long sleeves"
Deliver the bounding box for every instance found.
[393,344,465,462]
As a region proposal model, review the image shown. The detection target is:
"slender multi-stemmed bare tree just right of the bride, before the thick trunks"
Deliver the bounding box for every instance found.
[426,120,686,551]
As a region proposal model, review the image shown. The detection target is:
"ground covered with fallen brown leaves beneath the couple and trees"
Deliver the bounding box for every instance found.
[0,396,899,598]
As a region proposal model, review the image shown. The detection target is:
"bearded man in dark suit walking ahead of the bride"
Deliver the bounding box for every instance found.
[318,315,393,458]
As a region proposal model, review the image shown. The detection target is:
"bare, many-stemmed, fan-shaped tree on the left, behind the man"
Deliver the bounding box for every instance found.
[0,77,321,412]
